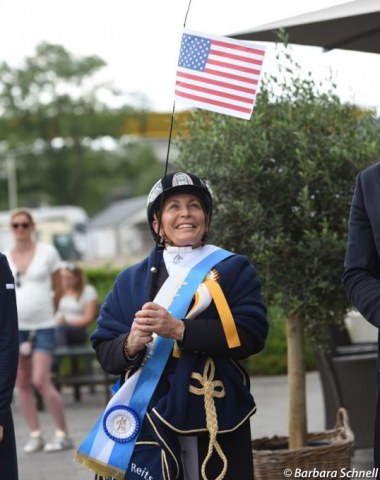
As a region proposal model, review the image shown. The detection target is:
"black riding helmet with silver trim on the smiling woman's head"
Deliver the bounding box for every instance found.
[147,172,212,240]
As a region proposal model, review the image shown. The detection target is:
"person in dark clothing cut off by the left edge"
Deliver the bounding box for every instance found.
[0,253,18,480]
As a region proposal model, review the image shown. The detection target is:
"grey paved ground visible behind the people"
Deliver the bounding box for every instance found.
[13,373,372,480]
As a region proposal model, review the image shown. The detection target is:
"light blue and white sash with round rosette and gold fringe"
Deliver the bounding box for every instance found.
[75,245,233,480]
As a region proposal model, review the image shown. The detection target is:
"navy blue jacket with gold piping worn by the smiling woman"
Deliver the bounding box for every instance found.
[91,246,268,478]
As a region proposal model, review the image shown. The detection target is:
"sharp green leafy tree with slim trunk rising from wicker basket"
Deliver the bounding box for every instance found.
[179,50,380,448]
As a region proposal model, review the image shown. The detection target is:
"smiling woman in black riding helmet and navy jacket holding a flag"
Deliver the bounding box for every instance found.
[92,172,268,480]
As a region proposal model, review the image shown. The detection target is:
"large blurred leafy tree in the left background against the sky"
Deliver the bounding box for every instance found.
[0,43,157,213]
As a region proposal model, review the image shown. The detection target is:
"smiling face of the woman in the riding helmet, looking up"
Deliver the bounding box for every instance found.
[153,194,206,247]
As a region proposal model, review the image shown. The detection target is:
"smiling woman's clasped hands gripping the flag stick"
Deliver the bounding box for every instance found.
[132,302,185,340]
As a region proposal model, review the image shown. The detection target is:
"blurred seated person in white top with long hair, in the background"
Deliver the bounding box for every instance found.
[56,263,98,346]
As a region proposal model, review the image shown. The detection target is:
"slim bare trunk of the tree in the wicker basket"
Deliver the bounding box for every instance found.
[286,315,307,449]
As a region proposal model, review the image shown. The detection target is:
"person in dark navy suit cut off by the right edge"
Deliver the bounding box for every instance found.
[343,163,380,472]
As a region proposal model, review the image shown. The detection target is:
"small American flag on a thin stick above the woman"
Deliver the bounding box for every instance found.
[175,30,265,120]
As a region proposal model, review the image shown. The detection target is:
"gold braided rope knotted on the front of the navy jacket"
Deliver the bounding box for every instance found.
[189,358,227,480]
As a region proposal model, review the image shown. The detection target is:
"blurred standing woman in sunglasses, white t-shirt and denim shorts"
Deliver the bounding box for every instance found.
[6,209,73,453]
